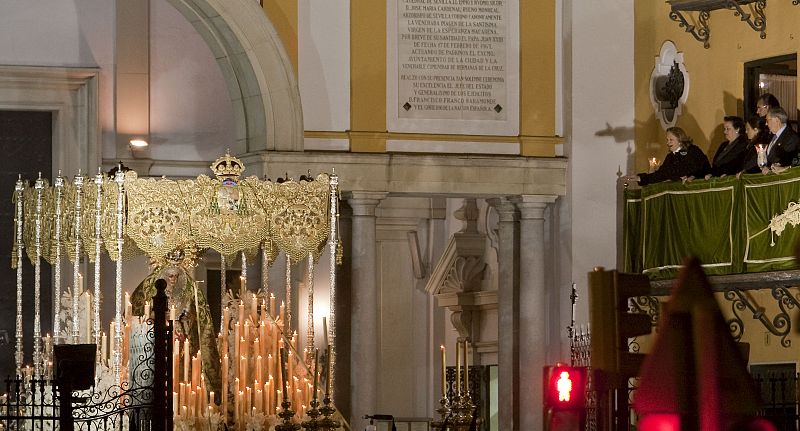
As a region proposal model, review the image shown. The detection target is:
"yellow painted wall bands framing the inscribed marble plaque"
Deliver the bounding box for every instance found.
[284,0,562,157]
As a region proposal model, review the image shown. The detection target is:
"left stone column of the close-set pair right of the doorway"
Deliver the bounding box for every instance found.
[487,198,520,431]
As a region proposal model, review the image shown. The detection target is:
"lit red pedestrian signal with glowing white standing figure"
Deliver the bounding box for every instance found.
[544,365,587,410]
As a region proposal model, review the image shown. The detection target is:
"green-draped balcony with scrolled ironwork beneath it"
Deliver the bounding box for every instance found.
[618,168,800,354]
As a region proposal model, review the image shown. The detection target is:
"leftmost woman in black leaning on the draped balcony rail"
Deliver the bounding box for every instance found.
[626,127,711,186]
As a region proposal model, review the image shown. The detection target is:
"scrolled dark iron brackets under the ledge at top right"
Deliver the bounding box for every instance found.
[667,0,764,48]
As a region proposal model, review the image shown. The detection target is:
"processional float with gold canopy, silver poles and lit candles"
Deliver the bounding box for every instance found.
[12,153,341,430]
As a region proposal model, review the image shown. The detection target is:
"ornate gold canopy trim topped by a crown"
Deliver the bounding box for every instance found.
[15,153,331,263]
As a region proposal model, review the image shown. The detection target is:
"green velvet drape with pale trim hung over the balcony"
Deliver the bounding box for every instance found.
[623,168,800,279]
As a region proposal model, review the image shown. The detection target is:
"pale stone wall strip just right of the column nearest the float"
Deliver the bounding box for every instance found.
[374,198,440,417]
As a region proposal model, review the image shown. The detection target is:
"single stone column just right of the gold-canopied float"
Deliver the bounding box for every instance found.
[346,192,387,430]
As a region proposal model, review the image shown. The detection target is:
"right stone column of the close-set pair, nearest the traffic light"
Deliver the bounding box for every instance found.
[516,195,555,430]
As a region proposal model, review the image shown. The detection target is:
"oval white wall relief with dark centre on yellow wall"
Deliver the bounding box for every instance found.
[650,40,689,130]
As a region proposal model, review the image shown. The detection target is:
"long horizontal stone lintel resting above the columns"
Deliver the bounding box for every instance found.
[241,151,567,197]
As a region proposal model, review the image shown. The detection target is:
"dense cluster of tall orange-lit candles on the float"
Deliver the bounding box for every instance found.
[172,289,330,427]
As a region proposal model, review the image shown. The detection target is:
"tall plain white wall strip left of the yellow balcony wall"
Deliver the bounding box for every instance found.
[564,0,634,328]
